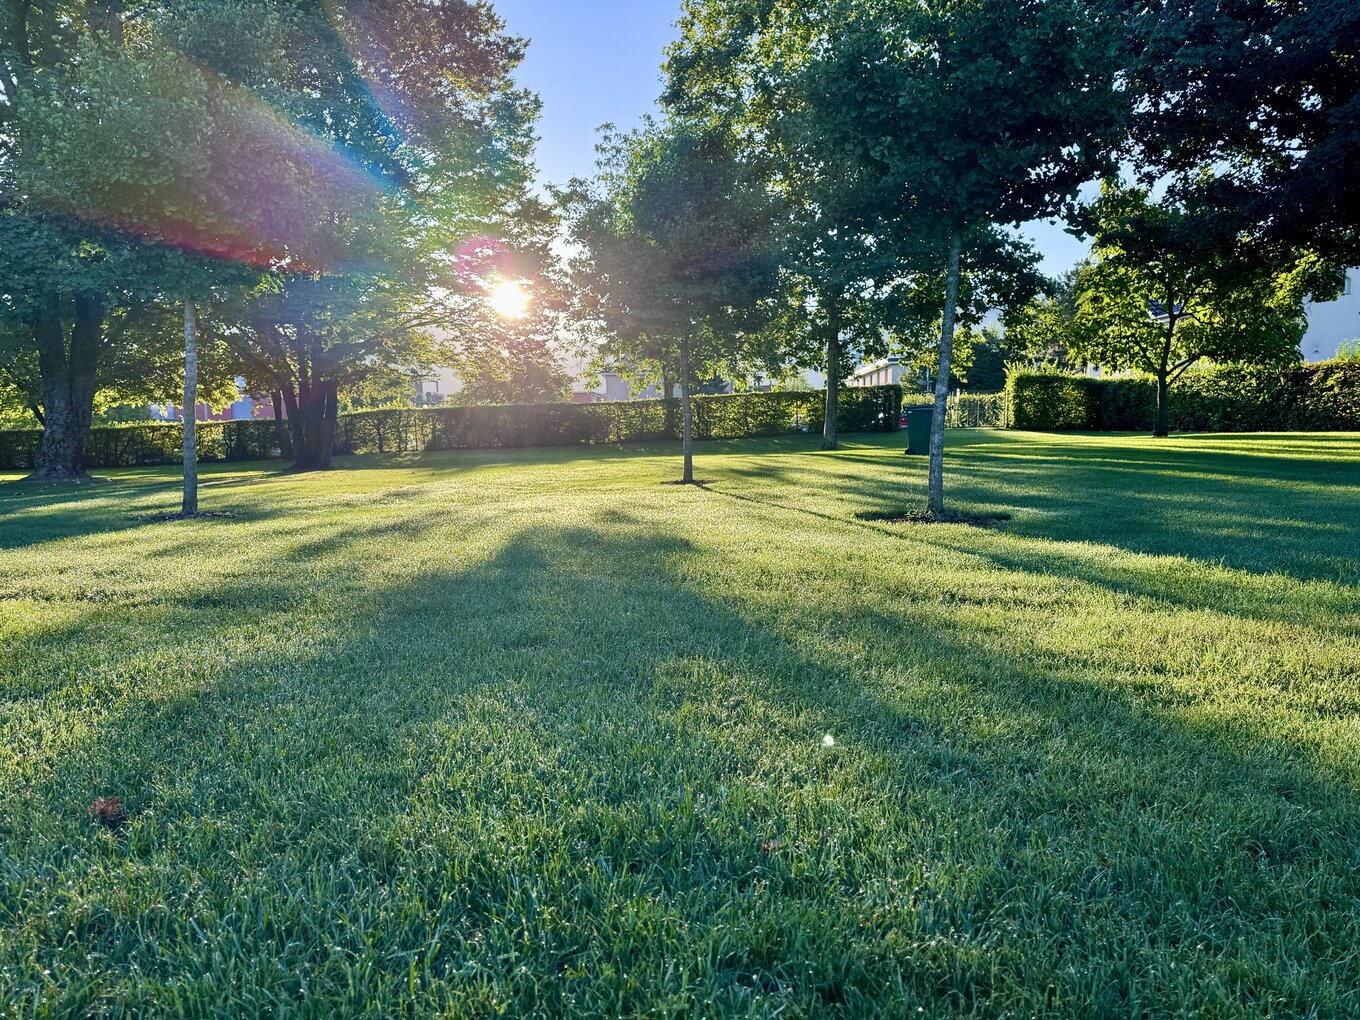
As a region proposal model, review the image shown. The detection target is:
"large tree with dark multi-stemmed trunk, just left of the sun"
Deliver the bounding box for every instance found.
[154,0,549,469]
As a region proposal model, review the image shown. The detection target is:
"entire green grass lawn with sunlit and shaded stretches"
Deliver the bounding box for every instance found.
[0,431,1360,1017]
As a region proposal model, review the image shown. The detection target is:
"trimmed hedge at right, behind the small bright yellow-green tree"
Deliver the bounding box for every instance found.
[1006,360,1360,432]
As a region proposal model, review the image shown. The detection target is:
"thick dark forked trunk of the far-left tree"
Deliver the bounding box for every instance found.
[30,296,103,483]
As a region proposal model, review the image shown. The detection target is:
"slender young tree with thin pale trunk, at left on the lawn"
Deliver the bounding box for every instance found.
[11,18,260,505]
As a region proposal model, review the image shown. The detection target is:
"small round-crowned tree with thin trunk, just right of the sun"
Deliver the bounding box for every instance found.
[563,121,779,484]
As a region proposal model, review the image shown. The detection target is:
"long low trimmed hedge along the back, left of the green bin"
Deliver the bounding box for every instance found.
[0,386,902,471]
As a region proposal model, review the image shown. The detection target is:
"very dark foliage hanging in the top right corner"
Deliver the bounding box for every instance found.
[1117,0,1360,265]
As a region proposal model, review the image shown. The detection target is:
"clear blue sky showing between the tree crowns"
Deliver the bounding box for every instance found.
[495,0,1085,273]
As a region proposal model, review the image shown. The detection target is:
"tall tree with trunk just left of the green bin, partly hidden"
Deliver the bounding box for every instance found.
[665,0,906,450]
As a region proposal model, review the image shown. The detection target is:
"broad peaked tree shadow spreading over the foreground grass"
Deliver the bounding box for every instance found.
[10,519,1360,1016]
